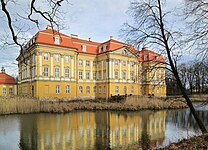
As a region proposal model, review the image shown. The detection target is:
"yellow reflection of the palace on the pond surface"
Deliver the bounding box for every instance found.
[20,111,166,150]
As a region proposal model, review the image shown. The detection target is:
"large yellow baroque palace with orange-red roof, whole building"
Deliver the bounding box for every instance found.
[17,26,166,99]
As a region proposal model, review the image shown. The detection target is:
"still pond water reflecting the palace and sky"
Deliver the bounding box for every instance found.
[0,104,208,150]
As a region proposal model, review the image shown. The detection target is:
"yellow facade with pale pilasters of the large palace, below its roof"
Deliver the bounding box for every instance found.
[17,28,166,99]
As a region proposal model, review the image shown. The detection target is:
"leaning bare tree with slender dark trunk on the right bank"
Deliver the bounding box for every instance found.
[124,0,207,133]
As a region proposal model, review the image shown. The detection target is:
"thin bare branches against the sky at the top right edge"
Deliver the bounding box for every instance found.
[185,0,208,60]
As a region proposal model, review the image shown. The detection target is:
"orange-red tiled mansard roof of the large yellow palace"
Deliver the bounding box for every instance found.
[29,29,165,62]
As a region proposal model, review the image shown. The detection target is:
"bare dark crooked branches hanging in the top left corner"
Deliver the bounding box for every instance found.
[0,0,68,62]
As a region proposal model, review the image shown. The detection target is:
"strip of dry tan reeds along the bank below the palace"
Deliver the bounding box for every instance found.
[0,97,186,114]
